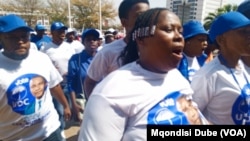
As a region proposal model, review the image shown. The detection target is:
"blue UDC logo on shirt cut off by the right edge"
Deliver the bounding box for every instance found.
[232,84,250,125]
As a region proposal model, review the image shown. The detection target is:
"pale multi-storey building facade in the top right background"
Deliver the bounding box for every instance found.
[167,0,232,23]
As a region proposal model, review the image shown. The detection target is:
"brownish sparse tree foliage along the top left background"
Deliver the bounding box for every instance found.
[0,0,117,29]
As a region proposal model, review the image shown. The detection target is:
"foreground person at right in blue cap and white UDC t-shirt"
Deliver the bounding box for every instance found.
[191,12,250,125]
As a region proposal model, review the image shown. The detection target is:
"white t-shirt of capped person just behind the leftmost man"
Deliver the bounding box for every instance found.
[40,42,75,76]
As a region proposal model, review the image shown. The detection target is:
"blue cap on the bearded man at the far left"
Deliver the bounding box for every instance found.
[0,14,33,33]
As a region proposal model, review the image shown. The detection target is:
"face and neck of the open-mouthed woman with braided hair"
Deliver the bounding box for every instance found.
[137,10,184,73]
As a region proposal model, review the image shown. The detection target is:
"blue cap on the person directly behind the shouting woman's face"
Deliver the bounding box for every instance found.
[182,20,208,40]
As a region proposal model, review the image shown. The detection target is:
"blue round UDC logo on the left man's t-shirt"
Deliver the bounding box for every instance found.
[6,74,46,115]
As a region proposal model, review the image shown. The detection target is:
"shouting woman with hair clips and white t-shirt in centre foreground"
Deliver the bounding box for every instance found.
[78,8,207,141]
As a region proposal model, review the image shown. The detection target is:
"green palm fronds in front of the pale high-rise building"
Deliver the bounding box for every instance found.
[204,4,238,30]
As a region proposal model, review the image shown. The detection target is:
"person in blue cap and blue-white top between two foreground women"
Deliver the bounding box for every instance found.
[178,20,208,82]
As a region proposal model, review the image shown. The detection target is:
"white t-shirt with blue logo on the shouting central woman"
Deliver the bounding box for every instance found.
[78,62,207,141]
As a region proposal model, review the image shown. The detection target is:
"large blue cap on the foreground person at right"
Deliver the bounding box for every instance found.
[209,11,250,43]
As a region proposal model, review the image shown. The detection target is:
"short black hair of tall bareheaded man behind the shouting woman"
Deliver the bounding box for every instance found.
[118,0,149,19]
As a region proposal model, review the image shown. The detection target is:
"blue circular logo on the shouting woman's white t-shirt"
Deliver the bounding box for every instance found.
[147,92,189,125]
